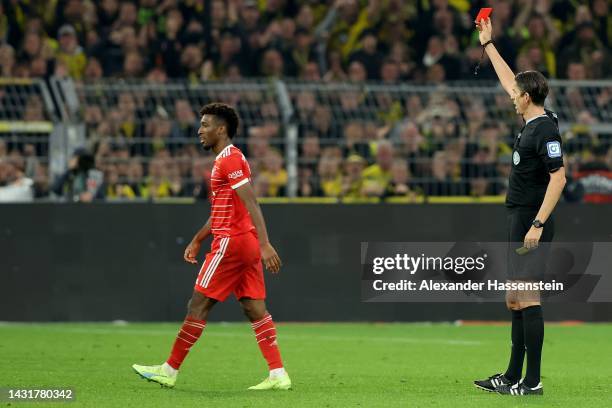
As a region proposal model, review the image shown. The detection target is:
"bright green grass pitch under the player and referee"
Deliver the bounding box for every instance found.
[0,323,612,408]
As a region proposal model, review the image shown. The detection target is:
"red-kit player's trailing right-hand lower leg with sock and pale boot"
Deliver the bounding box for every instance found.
[239,297,291,390]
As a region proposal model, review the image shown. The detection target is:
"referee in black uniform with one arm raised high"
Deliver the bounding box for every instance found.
[474,19,565,395]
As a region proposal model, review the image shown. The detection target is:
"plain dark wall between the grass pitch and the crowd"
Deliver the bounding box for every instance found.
[0,204,612,321]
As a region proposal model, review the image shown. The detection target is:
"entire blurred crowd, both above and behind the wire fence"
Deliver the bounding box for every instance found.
[0,0,612,201]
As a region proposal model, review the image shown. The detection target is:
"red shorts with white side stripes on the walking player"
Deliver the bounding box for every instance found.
[194,231,266,302]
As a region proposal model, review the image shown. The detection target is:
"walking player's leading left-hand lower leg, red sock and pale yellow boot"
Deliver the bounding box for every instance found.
[132,290,217,387]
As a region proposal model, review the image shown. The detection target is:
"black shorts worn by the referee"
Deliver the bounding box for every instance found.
[507,207,555,281]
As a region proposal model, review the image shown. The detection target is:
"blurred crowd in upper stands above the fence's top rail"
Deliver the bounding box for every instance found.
[0,0,612,83]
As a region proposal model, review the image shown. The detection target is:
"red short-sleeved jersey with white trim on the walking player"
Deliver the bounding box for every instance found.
[210,145,255,237]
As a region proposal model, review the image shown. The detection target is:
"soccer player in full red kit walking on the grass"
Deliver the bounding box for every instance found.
[132,103,291,390]
